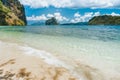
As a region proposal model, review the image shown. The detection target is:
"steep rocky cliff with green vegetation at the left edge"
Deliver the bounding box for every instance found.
[0,0,27,25]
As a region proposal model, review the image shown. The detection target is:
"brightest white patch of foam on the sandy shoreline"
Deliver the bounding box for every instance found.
[21,46,70,67]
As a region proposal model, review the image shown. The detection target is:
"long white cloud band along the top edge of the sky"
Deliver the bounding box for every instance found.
[20,0,120,8]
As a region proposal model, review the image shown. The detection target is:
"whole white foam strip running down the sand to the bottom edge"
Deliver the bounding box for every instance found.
[21,46,81,80]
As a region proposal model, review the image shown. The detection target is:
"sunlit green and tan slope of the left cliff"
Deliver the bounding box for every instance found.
[0,0,26,26]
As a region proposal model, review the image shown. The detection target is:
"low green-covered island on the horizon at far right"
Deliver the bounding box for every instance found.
[88,15,120,25]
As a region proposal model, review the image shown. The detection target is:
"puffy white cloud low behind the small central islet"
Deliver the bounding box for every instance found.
[27,12,69,22]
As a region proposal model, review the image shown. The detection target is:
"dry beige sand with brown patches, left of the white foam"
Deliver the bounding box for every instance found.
[0,42,78,80]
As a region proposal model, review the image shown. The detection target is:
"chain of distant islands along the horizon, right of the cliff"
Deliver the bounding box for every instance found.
[31,15,120,26]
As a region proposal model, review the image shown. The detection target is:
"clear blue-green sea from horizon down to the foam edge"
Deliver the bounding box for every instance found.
[0,25,120,80]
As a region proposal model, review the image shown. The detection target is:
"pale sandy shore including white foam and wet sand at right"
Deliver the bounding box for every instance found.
[0,41,120,80]
